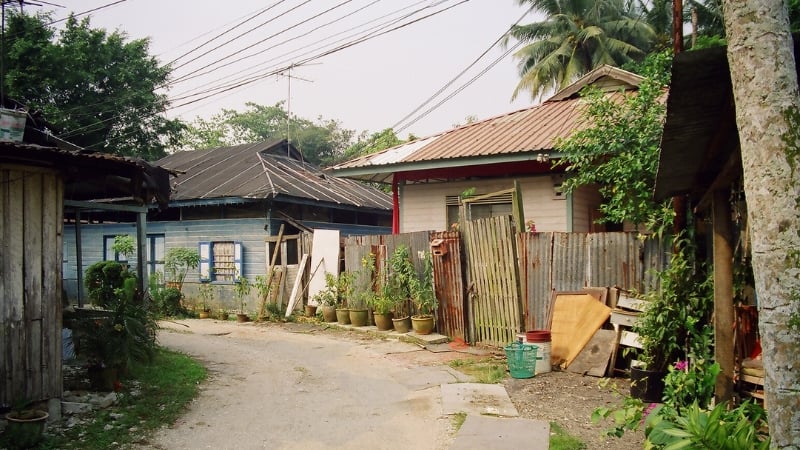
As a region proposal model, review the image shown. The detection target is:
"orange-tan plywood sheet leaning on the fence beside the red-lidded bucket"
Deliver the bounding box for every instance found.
[550,292,611,369]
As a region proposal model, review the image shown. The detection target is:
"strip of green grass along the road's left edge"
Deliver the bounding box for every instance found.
[38,348,208,450]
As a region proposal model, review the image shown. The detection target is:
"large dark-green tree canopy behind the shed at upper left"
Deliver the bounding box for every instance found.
[3,10,183,160]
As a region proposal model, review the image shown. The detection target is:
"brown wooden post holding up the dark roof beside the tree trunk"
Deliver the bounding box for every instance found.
[712,190,734,403]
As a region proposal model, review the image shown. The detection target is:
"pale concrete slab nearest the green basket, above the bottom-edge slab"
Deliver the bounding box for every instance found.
[442,383,519,417]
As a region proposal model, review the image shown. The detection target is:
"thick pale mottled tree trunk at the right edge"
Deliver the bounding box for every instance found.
[723,0,800,448]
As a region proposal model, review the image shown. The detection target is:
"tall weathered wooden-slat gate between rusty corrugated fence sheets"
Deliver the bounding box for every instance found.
[464,216,522,347]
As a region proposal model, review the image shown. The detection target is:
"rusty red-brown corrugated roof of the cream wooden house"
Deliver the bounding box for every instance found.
[327,66,642,183]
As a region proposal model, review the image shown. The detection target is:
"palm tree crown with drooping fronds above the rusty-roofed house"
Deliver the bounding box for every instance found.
[506,0,656,99]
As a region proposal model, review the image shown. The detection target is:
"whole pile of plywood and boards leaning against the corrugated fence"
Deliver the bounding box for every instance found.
[548,287,646,377]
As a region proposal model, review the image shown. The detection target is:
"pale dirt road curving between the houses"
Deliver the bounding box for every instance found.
[134,320,466,450]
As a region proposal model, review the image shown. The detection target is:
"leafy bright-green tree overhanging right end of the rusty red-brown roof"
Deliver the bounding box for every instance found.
[556,51,672,230]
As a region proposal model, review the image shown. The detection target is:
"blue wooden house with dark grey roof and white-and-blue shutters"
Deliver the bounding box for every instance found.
[64,140,392,307]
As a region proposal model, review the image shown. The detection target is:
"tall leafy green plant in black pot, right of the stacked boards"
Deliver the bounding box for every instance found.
[630,235,713,402]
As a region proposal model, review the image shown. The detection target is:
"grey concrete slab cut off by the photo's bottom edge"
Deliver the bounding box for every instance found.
[450,414,550,450]
